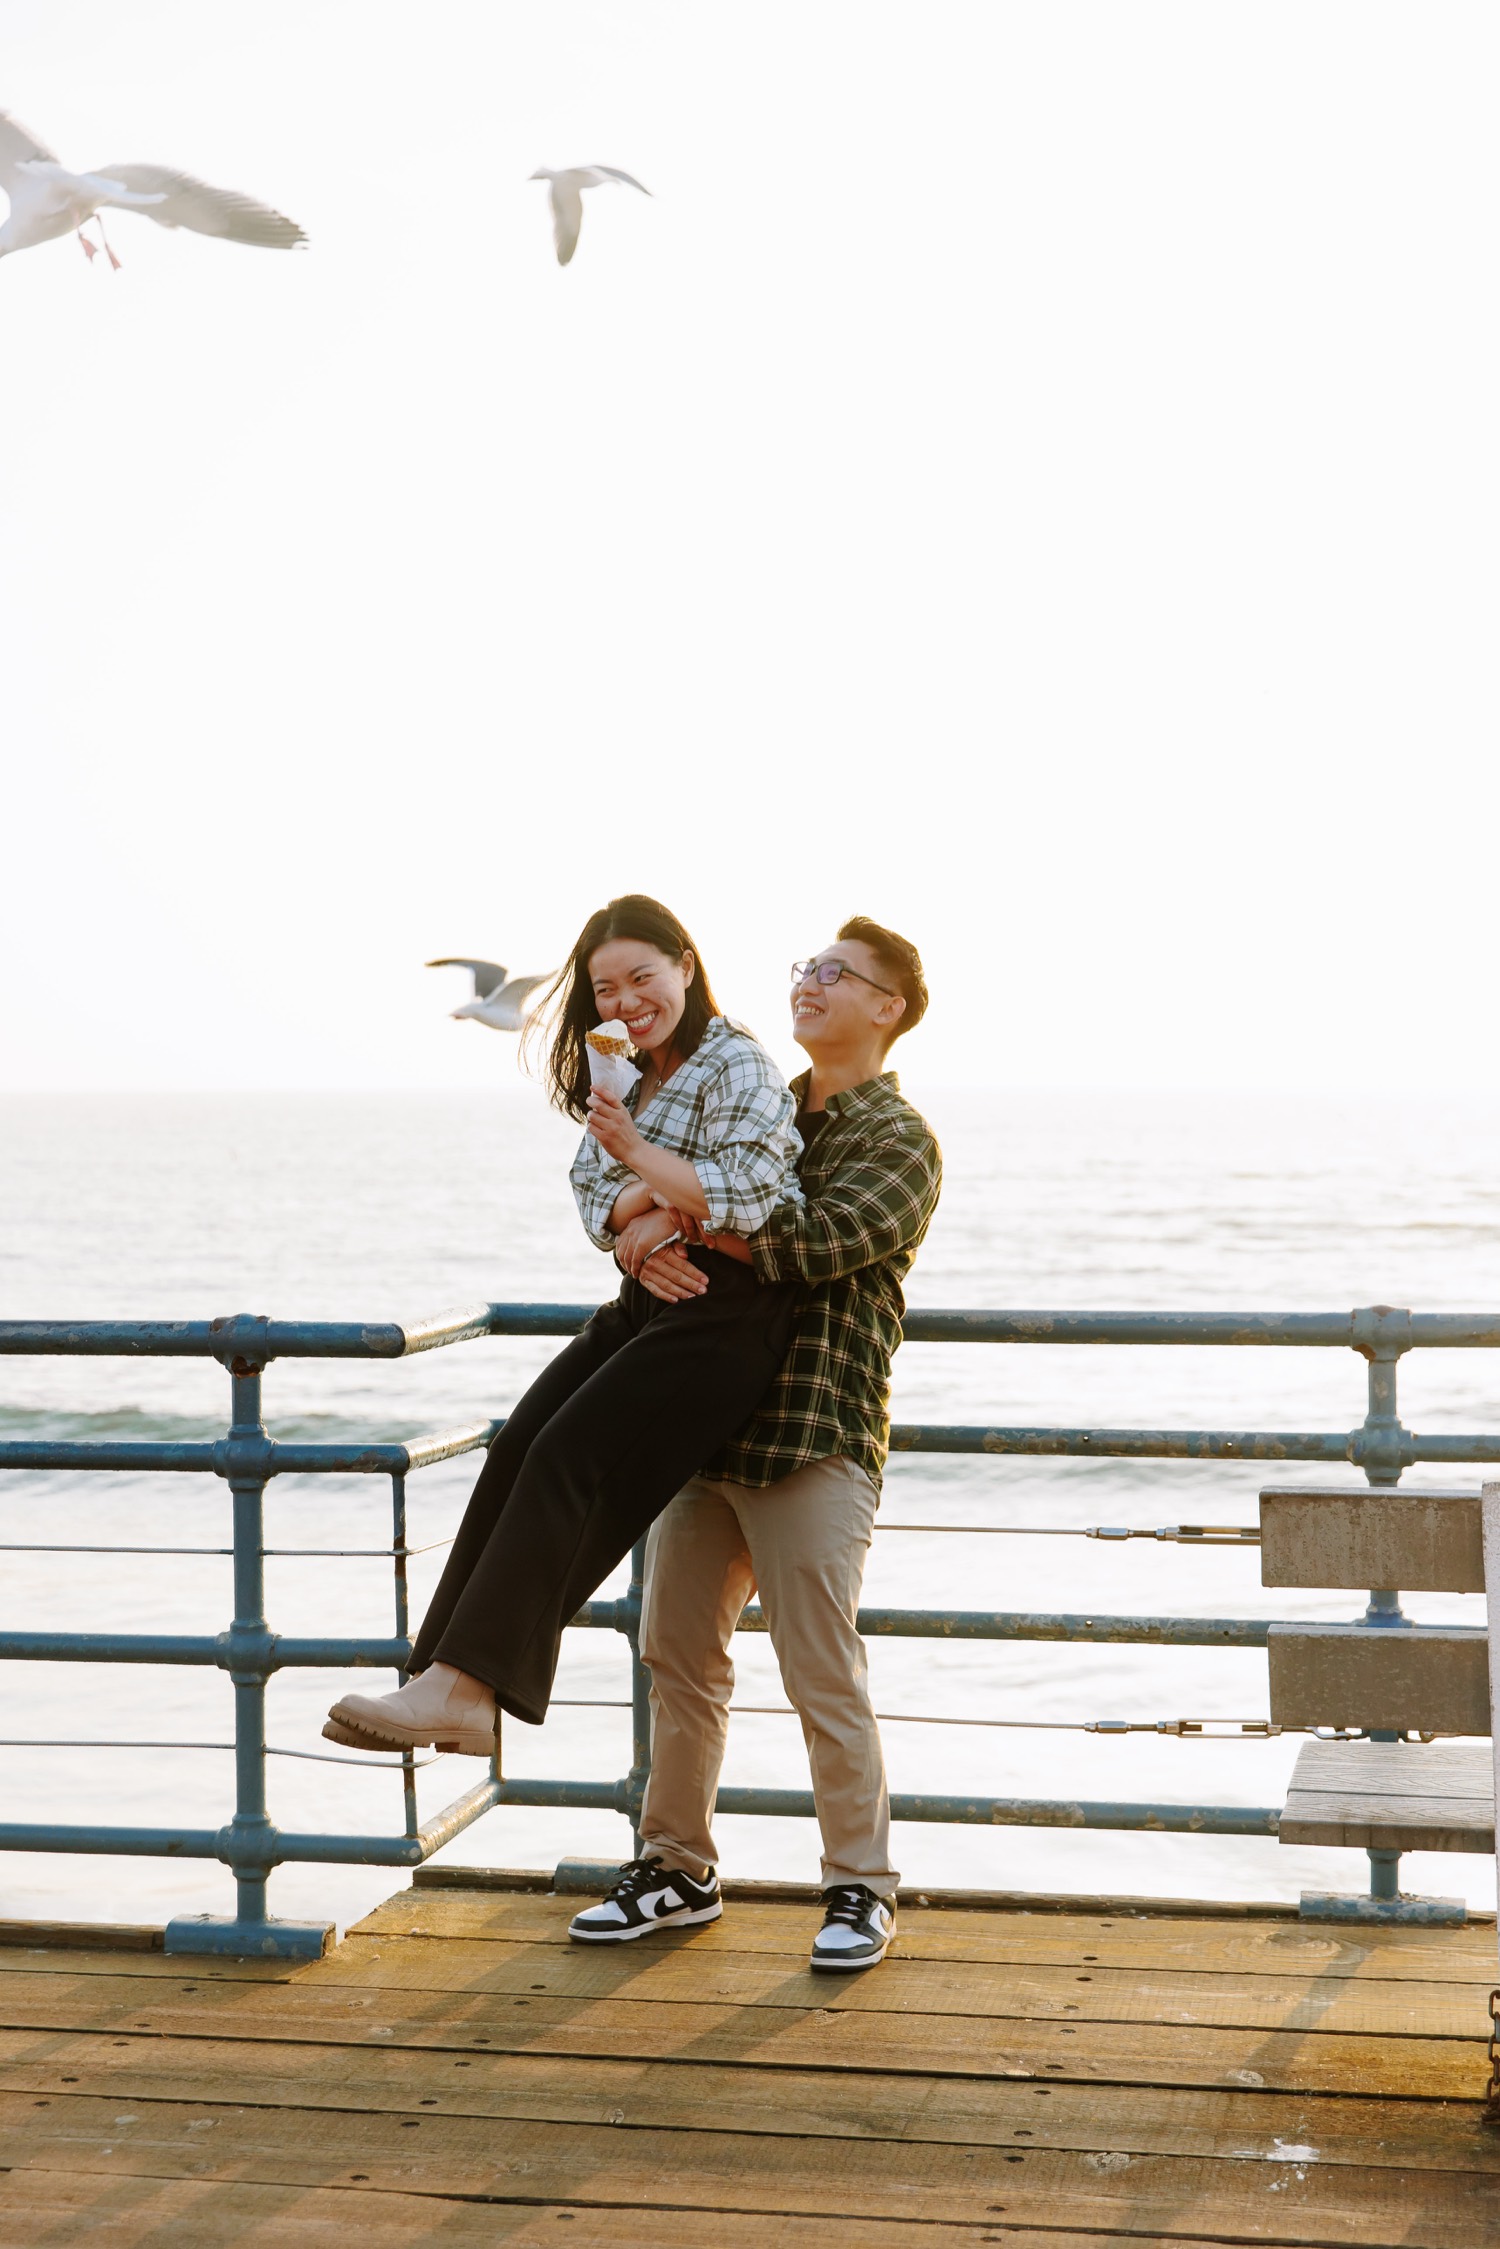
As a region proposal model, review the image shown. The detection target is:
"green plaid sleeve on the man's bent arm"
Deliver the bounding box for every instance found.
[751,1133,942,1282]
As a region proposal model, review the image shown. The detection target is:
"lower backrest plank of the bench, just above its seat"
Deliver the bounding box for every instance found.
[1266,1624,1491,1736]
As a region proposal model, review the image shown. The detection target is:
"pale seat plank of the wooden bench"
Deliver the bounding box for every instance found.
[1282,1741,1496,1853]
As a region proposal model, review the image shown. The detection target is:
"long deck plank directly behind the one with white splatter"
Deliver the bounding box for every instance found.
[7,1977,1487,2101]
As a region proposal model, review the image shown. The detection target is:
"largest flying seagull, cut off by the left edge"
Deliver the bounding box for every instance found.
[0,110,306,270]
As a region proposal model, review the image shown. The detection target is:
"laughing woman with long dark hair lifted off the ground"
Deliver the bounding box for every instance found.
[324,897,801,1756]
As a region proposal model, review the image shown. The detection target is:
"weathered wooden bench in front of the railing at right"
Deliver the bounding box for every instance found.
[1259,1484,1500,1921]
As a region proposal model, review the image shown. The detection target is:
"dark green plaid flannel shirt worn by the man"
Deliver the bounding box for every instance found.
[704,1071,942,1489]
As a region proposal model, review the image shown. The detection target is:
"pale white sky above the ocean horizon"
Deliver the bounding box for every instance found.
[0,0,1500,1093]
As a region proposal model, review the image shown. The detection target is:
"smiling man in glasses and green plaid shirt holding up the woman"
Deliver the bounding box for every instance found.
[569,915,942,1970]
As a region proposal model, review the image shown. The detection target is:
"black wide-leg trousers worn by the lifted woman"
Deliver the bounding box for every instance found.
[412,1250,796,1725]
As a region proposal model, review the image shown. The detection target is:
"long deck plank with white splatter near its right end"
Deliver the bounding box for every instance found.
[0,2031,1500,2173]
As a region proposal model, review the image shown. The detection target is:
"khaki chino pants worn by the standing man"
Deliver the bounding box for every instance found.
[641,1460,900,1896]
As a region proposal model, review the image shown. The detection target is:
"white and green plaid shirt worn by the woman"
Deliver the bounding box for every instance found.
[569,1014,803,1250]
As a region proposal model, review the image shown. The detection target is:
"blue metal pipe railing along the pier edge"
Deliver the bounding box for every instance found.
[0,1304,1500,1957]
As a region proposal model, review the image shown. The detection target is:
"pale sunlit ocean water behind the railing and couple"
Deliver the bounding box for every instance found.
[0,1084,1500,1923]
